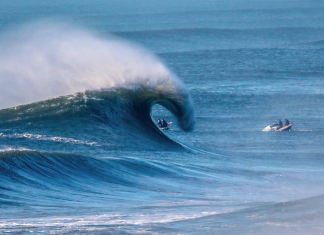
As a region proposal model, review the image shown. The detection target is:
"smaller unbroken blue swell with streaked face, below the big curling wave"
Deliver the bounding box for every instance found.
[0,150,205,211]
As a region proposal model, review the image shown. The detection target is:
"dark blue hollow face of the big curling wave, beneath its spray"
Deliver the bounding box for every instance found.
[0,88,194,152]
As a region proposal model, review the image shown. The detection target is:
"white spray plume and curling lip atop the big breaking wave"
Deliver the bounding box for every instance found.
[0,21,194,131]
